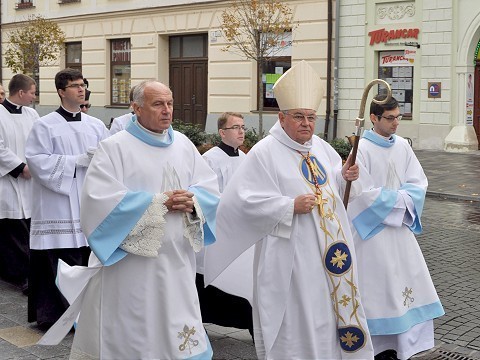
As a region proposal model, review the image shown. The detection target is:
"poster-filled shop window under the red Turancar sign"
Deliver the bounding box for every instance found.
[378,51,413,119]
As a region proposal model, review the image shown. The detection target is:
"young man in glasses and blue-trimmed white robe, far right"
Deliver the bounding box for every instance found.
[348,95,444,360]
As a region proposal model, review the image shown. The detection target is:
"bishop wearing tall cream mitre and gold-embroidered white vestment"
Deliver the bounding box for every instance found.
[205,61,373,359]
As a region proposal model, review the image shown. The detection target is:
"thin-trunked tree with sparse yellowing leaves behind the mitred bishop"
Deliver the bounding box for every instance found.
[220,0,294,137]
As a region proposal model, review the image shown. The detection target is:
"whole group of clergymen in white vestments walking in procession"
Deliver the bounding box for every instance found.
[0,61,444,360]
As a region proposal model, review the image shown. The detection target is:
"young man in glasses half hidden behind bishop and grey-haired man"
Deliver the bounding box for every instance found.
[196,112,253,336]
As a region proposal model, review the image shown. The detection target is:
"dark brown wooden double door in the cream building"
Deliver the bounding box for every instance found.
[170,60,207,129]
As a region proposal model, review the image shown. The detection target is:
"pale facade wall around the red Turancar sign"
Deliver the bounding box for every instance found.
[337,0,458,149]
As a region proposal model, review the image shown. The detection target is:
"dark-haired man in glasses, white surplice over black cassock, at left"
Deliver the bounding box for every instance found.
[25,68,109,328]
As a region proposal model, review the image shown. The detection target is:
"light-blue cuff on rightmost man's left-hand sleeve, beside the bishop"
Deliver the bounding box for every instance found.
[352,188,397,240]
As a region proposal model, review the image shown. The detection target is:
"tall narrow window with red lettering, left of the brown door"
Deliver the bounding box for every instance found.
[111,39,131,106]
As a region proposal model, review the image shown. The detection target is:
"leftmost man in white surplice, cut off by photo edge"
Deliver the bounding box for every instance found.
[0,74,39,293]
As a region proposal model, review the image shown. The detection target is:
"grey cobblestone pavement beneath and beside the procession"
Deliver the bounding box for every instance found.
[0,151,480,360]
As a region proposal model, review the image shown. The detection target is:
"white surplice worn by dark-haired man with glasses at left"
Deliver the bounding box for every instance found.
[25,112,109,250]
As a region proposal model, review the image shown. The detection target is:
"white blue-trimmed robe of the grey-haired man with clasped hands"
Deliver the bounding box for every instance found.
[60,123,219,360]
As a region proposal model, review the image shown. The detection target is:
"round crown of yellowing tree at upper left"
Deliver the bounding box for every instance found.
[5,15,65,77]
